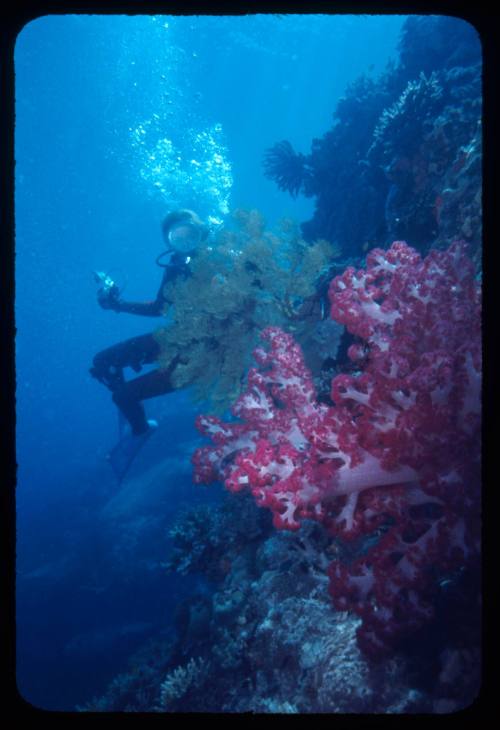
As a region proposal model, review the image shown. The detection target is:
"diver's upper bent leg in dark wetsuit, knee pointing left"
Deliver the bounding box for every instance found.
[90,334,160,391]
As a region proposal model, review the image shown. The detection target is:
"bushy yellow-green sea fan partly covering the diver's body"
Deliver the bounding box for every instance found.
[155,210,338,412]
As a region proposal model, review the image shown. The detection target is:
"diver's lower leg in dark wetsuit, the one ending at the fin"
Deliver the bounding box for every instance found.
[113,360,177,435]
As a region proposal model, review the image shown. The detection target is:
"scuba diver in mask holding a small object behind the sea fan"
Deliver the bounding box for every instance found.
[90,209,209,481]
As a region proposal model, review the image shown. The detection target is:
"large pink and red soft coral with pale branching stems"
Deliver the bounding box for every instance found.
[193,242,481,655]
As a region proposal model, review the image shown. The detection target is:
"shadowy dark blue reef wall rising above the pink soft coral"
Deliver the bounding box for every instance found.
[264,16,481,257]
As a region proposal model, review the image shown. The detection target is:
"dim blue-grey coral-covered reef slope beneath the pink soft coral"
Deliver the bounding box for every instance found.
[80,495,479,714]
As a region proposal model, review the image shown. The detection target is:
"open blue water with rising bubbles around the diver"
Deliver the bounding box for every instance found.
[15,15,404,709]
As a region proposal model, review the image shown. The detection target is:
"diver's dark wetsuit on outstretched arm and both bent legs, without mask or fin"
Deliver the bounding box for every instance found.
[90,254,191,434]
